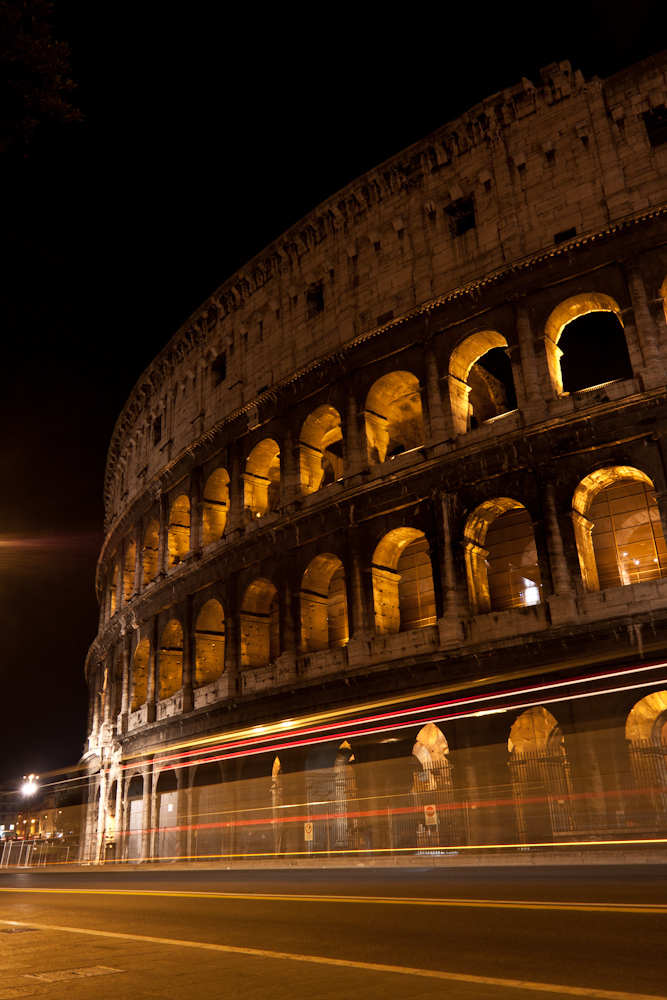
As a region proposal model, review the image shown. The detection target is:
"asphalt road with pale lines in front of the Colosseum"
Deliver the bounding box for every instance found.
[0,865,667,1000]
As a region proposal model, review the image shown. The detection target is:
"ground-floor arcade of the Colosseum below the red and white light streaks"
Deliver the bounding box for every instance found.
[89,692,667,860]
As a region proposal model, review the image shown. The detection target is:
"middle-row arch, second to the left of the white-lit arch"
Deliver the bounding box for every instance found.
[301,552,349,653]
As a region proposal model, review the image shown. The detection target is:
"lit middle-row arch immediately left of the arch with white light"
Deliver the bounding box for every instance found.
[373,528,436,634]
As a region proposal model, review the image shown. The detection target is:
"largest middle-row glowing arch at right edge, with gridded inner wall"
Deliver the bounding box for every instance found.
[572,465,667,590]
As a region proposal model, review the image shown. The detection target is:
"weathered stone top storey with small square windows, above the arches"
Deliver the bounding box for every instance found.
[106,57,667,524]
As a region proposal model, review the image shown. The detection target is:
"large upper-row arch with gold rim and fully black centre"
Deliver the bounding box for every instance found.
[544,292,633,395]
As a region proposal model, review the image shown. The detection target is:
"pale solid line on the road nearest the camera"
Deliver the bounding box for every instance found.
[0,920,667,1000]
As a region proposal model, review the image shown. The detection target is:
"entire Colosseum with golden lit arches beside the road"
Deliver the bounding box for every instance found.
[81,53,667,861]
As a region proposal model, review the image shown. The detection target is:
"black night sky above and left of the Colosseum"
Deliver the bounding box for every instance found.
[0,0,667,785]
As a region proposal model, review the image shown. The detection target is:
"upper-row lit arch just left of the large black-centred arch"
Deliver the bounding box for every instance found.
[448,330,516,434]
